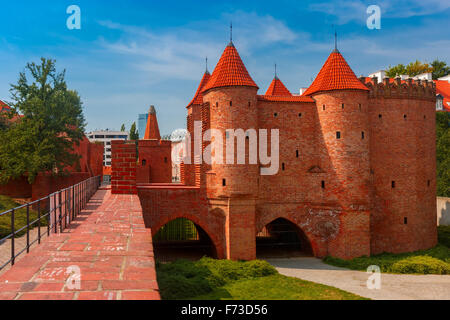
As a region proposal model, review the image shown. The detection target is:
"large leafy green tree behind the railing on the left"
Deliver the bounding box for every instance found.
[0,58,85,183]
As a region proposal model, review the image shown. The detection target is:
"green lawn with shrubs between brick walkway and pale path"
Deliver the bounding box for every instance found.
[156,258,364,300]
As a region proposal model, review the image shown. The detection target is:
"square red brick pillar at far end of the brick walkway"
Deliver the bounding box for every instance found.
[111,140,137,194]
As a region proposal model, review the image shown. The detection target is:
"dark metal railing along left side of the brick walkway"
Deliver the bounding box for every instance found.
[0,176,101,270]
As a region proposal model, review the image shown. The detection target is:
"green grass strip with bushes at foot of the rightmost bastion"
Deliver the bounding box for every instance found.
[324,226,450,274]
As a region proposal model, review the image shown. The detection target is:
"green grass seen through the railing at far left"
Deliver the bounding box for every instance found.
[0,195,47,239]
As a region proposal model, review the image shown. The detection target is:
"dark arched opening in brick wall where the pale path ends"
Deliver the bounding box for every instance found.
[256,217,313,258]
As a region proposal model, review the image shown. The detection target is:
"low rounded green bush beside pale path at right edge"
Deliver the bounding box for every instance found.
[391,256,450,274]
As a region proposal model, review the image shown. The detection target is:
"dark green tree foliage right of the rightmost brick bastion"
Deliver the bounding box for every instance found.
[436,112,450,197]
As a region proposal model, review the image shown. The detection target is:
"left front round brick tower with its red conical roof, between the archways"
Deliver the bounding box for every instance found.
[202,42,259,259]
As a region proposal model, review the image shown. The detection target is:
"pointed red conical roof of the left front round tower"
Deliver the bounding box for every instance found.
[202,42,258,92]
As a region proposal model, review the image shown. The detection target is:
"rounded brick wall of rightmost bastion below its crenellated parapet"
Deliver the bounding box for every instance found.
[370,87,437,254]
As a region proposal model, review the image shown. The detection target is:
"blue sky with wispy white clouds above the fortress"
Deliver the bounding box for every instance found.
[0,0,450,134]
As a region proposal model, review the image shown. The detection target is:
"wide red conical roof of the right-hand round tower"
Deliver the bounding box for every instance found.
[303,50,369,95]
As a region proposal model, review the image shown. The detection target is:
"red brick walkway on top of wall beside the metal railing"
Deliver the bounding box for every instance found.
[0,190,160,300]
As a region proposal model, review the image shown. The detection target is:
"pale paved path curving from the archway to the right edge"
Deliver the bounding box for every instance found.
[267,257,450,300]
